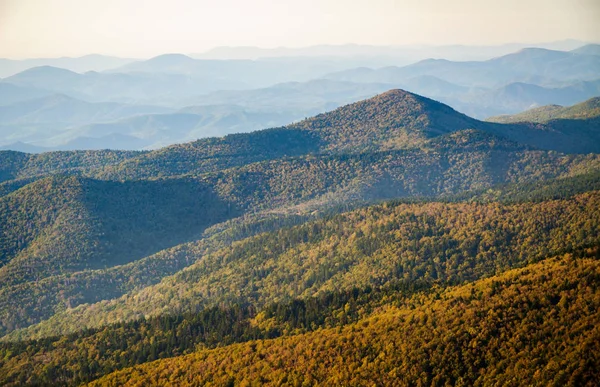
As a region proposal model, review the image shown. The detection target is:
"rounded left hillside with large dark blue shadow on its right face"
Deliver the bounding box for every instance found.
[0,177,236,285]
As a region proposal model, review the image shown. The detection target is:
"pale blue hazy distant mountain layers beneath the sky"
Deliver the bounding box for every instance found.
[0,44,600,152]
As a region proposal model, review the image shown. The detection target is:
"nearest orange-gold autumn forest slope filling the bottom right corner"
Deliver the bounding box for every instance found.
[90,254,600,386]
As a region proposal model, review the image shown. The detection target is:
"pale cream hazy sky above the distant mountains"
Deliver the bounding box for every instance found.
[0,0,600,58]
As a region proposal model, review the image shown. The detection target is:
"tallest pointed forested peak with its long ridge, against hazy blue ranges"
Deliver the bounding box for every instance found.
[44,90,600,183]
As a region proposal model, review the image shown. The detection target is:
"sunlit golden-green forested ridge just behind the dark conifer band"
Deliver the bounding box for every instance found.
[5,192,600,340]
